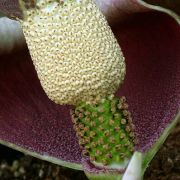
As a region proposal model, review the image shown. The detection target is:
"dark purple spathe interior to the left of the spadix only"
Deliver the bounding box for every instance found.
[0,48,81,163]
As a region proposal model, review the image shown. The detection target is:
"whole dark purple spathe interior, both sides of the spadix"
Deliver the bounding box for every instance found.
[0,10,180,163]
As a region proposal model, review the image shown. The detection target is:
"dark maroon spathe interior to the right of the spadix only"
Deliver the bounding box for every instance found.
[116,13,180,151]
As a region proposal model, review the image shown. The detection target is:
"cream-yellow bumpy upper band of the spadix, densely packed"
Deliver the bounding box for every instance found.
[21,0,125,105]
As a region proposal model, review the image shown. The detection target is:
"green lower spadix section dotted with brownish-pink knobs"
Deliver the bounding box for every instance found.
[71,95,136,168]
